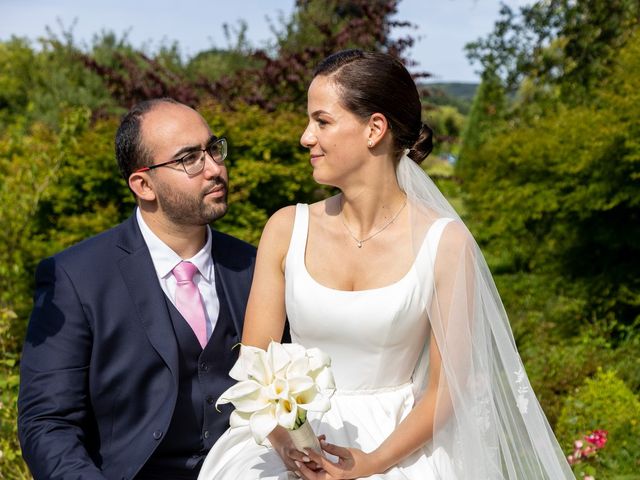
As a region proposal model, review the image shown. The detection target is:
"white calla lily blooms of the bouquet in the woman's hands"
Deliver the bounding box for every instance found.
[216,341,335,444]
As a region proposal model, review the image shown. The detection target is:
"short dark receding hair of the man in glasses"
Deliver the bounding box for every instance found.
[116,97,181,183]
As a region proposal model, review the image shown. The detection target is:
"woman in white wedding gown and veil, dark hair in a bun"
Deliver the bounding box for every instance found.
[199,50,574,480]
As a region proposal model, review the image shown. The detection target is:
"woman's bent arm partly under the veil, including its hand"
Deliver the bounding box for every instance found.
[302,222,474,479]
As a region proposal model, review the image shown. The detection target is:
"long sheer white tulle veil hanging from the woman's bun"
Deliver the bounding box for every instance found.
[397,155,575,480]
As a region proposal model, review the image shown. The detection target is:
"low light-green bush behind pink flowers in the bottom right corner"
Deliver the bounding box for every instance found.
[556,371,640,480]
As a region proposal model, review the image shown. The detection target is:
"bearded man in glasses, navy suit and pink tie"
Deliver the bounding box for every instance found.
[18,99,255,480]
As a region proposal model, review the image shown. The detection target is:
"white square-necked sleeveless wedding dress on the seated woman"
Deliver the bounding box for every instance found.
[198,204,456,480]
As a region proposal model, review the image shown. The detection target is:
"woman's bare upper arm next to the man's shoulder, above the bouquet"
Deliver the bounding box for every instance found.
[242,206,295,349]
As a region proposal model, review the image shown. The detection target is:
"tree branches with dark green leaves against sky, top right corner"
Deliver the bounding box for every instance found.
[466,0,640,97]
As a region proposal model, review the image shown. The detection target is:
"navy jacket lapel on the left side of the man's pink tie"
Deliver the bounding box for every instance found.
[118,216,178,381]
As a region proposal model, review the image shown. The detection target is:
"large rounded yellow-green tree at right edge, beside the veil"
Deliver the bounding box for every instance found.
[459,29,640,325]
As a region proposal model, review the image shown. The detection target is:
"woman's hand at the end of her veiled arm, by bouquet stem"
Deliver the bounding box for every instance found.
[298,436,379,480]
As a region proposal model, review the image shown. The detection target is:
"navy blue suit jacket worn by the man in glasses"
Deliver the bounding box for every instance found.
[18,216,255,480]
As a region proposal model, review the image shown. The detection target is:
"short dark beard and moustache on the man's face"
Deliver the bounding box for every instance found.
[158,177,229,225]
